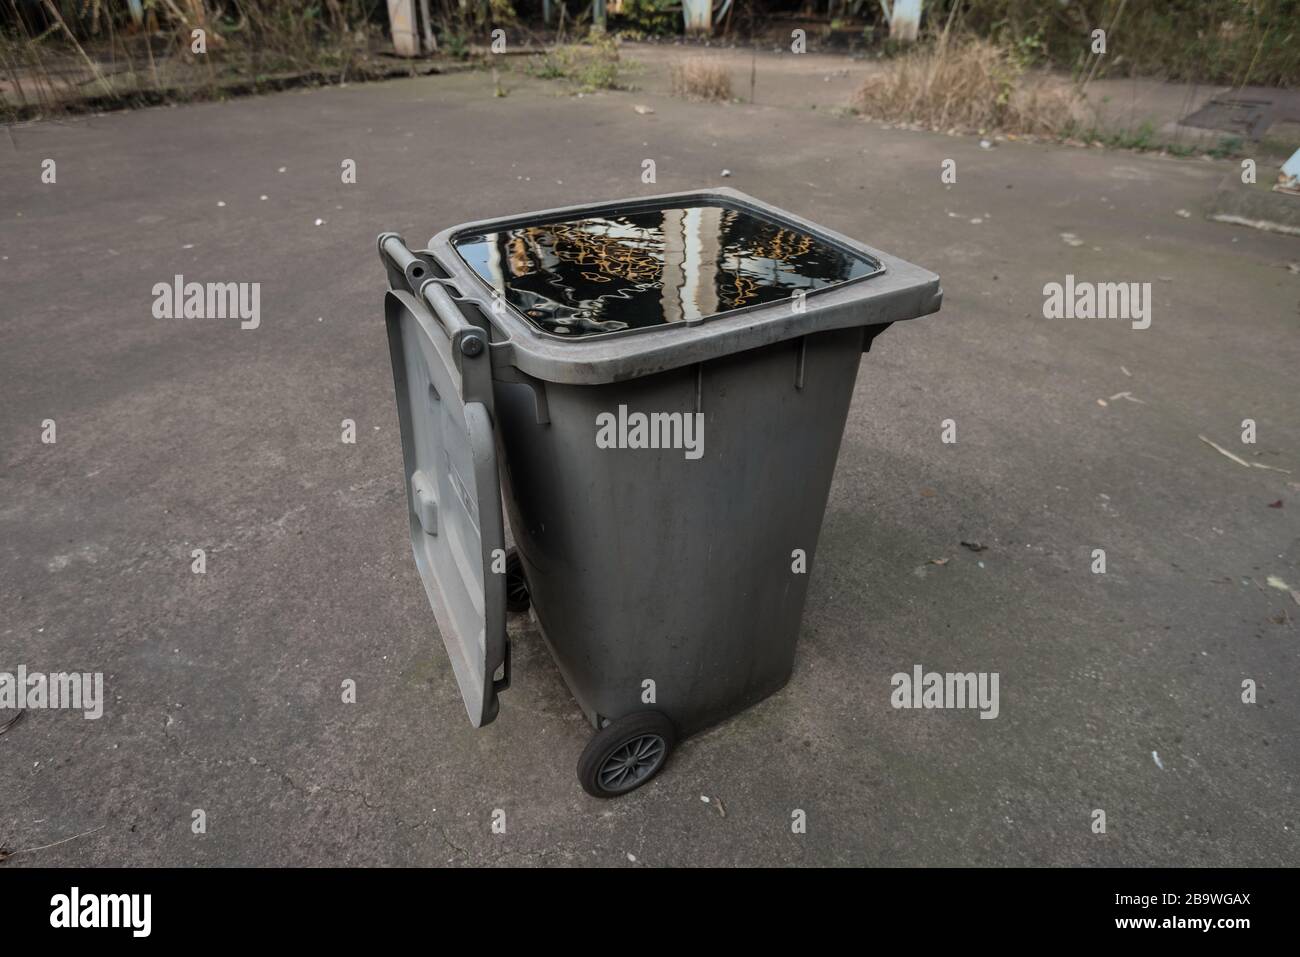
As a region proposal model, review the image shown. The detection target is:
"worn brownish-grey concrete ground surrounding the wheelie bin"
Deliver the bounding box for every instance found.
[0,52,1300,866]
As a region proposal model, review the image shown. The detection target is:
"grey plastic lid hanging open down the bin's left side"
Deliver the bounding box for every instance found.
[385,289,510,727]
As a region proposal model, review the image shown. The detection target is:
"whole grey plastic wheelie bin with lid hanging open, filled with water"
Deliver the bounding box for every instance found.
[380,190,943,797]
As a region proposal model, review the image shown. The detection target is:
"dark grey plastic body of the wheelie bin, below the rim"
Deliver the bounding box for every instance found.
[495,328,863,735]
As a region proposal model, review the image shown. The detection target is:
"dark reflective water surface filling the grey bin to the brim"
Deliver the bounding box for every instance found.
[455,205,879,338]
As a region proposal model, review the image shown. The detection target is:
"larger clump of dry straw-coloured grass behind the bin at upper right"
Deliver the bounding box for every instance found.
[854,39,1087,135]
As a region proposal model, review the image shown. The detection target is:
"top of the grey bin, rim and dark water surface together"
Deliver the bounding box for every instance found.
[429,189,943,385]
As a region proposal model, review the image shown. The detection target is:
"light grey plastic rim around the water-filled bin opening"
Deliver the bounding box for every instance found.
[426,187,943,385]
